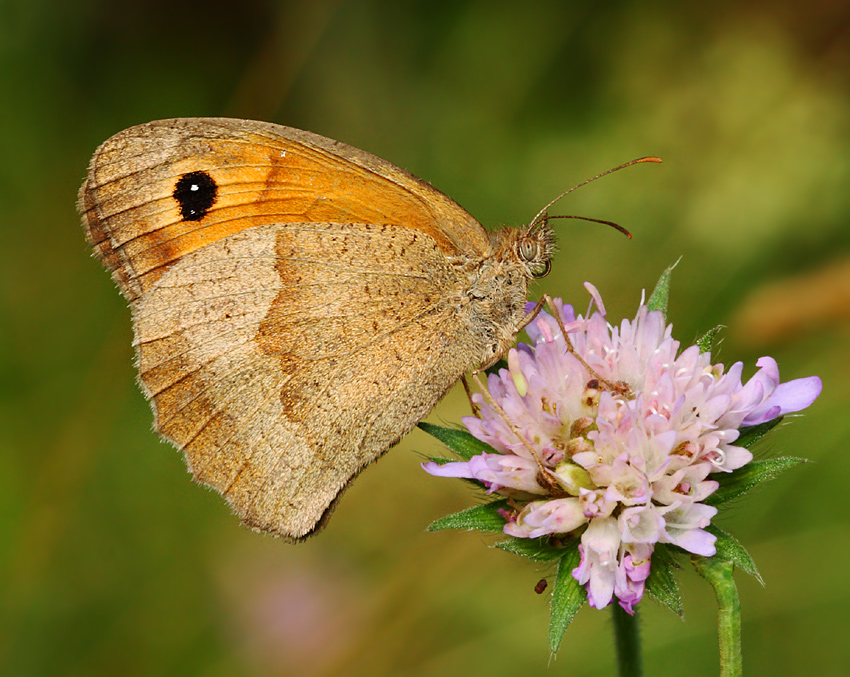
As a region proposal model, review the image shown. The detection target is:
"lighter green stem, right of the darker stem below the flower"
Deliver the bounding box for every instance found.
[691,557,743,677]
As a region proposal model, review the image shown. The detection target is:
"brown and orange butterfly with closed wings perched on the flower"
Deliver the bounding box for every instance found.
[79,118,554,539]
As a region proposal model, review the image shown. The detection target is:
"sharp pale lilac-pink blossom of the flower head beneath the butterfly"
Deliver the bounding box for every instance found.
[423,284,821,613]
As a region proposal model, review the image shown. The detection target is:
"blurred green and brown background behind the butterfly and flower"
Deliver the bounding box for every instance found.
[0,0,850,677]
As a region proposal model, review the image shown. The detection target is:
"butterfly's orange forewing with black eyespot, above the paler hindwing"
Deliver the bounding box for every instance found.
[80,120,489,301]
